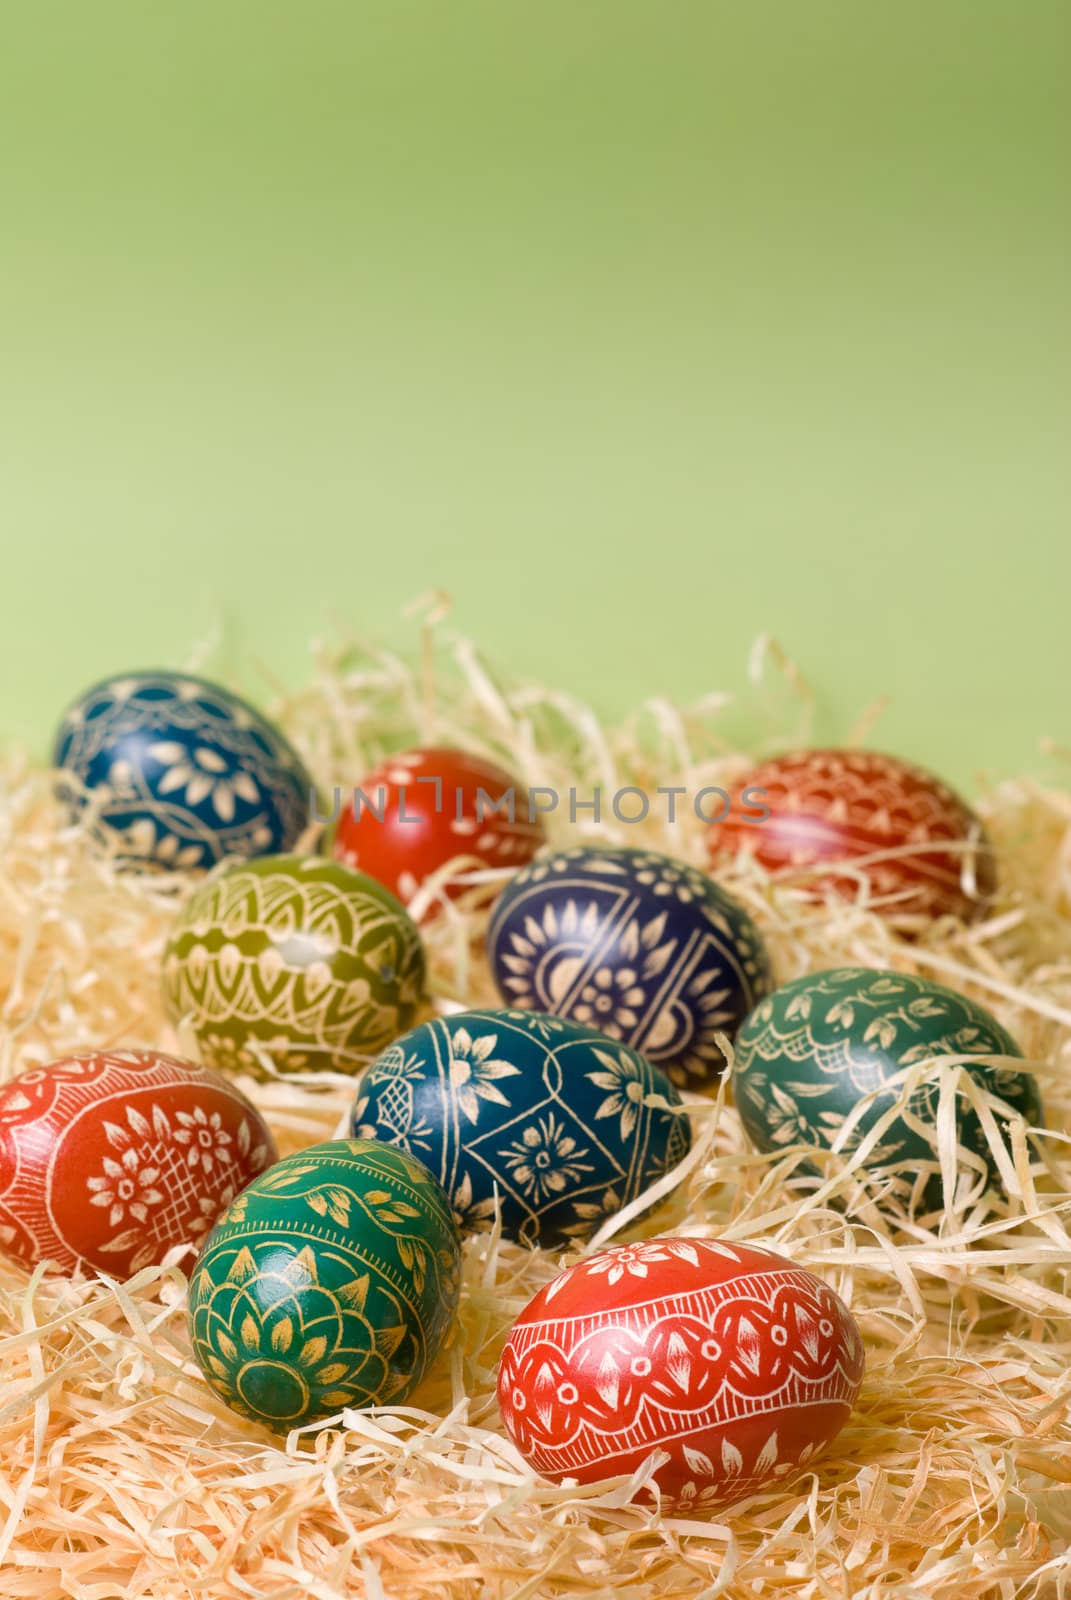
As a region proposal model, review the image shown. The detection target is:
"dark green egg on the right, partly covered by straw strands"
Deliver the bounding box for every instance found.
[733,966,1042,1210]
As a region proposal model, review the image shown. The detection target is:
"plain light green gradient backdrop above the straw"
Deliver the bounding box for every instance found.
[0,0,1071,784]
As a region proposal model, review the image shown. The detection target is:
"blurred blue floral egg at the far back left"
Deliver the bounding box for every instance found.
[53,672,312,869]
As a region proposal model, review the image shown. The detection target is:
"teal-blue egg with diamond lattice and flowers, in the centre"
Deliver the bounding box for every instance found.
[352,1011,692,1246]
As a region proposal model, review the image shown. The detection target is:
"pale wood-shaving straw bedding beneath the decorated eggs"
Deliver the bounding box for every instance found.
[0,601,1071,1600]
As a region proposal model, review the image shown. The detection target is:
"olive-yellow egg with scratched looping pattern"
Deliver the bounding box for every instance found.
[163,856,424,1072]
